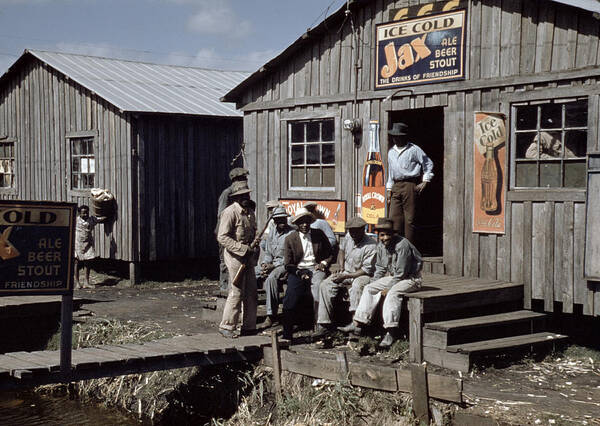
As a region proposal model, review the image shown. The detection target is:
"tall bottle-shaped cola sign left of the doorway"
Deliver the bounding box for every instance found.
[361,121,385,224]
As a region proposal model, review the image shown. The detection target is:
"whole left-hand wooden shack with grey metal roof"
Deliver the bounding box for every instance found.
[0,50,248,280]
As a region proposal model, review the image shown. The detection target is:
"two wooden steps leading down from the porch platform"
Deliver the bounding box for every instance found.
[423,310,567,372]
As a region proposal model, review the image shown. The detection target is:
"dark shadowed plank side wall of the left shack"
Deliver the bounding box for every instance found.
[134,115,242,261]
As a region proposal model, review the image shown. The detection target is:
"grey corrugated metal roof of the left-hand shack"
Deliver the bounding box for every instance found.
[22,50,249,116]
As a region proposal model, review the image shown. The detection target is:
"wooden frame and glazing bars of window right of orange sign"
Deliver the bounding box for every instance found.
[508,97,590,191]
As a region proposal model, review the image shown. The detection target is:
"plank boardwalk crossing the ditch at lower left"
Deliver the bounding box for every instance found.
[0,333,271,390]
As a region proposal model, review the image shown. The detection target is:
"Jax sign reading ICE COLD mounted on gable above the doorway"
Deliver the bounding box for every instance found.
[375,10,466,89]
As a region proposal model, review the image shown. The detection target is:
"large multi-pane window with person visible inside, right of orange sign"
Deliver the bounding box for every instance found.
[512,98,588,188]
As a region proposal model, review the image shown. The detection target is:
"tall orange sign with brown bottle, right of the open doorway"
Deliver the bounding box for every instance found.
[473,112,506,234]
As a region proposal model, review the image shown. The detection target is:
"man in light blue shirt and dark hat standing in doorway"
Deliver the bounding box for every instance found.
[385,123,433,242]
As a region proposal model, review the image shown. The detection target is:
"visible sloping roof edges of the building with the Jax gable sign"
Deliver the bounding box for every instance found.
[221,0,600,102]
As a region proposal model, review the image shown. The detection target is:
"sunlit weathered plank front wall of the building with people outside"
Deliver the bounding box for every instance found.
[238,0,600,315]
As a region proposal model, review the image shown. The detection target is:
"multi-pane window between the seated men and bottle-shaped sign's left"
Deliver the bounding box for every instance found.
[288,118,335,190]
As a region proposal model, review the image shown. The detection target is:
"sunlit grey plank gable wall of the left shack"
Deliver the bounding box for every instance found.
[0,60,133,261]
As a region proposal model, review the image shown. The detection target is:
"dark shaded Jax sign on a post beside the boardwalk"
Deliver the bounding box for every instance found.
[0,200,77,296]
